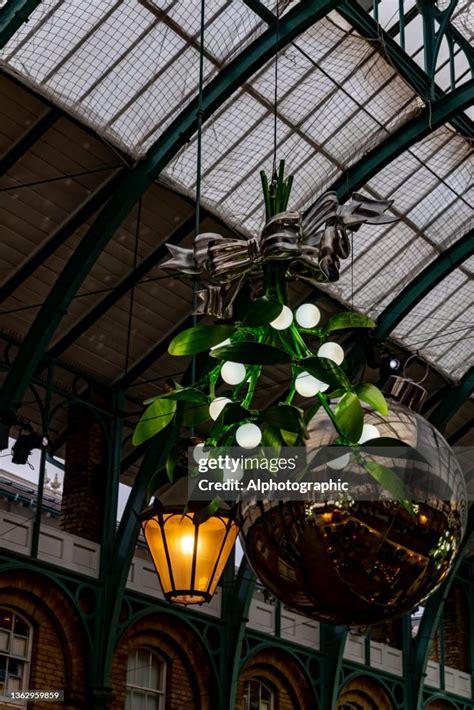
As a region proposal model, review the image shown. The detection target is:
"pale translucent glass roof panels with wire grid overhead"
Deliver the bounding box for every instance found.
[0,0,474,394]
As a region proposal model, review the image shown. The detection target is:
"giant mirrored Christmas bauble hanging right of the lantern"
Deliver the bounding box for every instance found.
[240,378,467,626]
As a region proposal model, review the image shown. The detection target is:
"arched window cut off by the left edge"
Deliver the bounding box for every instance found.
[0,607,32,695]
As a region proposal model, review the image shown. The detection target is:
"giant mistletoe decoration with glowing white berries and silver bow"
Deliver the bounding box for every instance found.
[134,161,408,495]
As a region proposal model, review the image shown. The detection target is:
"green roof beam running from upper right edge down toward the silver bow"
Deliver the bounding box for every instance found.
[330,79,474,209]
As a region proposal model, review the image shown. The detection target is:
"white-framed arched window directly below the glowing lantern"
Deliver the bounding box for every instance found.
[125,648,166,710]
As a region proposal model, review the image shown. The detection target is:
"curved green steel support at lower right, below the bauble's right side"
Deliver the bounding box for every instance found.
[406,506,474,708]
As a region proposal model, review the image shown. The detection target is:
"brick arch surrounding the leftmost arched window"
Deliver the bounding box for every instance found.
[0,572,86,710]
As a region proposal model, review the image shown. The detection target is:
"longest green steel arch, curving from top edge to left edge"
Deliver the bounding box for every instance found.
[0,0,340,412]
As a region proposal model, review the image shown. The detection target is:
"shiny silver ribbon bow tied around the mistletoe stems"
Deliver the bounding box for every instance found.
[161,192,397,318]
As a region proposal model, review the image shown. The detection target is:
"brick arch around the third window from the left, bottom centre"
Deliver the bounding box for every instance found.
[236,648,316,710]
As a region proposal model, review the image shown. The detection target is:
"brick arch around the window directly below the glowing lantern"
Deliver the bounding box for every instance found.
[107,614,213,710]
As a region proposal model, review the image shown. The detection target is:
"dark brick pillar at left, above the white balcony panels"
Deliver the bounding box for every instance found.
[60,402,107,542]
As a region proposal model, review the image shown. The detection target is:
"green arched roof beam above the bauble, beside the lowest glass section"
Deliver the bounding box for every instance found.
[374,229,474,340]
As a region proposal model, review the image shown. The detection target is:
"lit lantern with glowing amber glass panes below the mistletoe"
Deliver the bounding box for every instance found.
[139,479,239,604]
